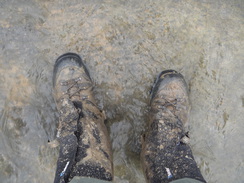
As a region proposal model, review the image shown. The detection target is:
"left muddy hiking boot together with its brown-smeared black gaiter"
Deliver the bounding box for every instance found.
[53,53,113,183]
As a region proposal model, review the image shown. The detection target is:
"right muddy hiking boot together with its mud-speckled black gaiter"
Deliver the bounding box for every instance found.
[141,70,205,183]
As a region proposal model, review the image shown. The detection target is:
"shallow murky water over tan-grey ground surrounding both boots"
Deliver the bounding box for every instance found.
[0,0,244,183]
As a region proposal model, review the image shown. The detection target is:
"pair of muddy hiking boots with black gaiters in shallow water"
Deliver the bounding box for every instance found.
[53,53,205,183]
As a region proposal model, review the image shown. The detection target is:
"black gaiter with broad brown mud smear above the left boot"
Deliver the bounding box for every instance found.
[54,100,113,183]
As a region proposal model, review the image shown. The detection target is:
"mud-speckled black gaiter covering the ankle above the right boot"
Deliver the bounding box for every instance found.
[142,118,205,183]
